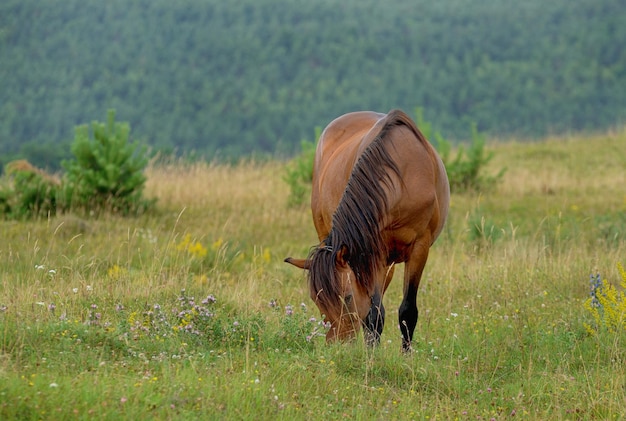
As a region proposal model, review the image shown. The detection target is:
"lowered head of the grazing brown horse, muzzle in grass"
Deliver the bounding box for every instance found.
[285,246,372,342]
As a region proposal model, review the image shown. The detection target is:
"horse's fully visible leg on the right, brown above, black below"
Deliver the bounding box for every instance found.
[398,244,428,352]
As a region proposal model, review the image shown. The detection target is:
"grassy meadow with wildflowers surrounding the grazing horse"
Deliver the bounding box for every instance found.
[0,131,626,420]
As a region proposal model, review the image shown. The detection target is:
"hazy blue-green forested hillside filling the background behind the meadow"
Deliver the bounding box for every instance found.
[0,0,626,169]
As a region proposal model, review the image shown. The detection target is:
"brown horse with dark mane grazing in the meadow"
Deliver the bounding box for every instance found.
[285,110,450,351]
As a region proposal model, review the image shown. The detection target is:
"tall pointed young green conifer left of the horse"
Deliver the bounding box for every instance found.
[62,110,152,214]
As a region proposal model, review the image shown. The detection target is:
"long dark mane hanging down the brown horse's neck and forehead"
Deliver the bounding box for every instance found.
[309,110,414,308]
